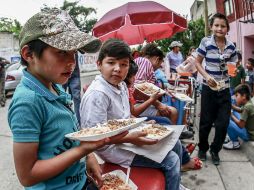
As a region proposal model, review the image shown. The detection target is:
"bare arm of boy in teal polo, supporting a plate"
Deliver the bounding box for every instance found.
[13,133,127,187]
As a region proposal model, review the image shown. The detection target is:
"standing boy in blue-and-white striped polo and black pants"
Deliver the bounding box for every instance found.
[188,13,238,165]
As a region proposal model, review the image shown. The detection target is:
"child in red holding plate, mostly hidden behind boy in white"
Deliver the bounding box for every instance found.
[124,61,202,171]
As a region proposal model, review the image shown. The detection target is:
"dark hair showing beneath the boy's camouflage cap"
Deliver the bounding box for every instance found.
[21,40,49,66]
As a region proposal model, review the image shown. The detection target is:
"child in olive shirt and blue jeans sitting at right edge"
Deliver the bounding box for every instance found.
[223,84,254,150]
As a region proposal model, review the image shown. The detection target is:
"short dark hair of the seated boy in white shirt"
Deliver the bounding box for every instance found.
[98,38,132,61]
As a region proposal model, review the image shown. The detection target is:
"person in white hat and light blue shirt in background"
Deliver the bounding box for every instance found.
[165,41,184,74]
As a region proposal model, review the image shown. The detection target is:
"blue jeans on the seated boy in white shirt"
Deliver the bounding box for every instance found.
[131,141,182,190]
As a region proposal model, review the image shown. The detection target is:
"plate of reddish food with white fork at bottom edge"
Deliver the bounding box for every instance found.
[100,170,138,190]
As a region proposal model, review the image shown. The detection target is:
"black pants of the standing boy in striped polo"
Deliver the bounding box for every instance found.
[198,85,231,153]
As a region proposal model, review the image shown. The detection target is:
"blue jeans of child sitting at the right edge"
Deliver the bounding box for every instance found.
[228,112,249,142]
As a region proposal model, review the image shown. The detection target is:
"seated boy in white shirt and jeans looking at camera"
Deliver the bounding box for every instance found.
[80,39,188,190]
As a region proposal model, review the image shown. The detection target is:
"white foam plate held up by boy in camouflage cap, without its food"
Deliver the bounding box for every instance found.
[65,117,147,141]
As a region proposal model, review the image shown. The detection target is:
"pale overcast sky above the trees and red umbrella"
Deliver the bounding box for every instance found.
[0,0,194,25]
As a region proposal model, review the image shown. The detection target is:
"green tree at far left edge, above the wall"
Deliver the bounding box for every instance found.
[0,17,22,37]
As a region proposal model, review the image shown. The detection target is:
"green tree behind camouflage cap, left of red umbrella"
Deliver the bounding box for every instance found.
[60,0,97,32]
